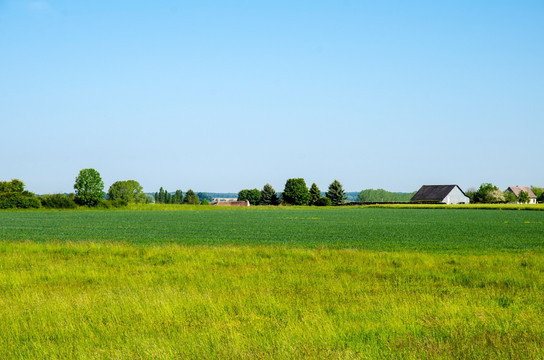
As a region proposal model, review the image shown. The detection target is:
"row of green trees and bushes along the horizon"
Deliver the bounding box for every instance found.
[0,169,544,209]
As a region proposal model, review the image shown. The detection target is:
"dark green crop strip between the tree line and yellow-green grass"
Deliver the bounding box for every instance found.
[0,207,544,254]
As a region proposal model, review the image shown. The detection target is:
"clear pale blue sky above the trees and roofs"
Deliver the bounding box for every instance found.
[0,0,544,193]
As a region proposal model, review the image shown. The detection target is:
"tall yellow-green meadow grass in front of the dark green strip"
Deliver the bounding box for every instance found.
[0,242,544,359]
